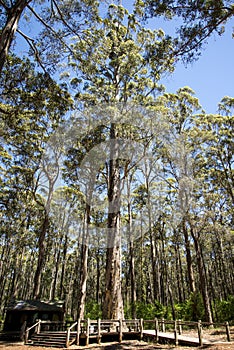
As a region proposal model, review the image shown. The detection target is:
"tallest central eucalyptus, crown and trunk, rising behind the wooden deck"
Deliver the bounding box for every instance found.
[63,5,173,318]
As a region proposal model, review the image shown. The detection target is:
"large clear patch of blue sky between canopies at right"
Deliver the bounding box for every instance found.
[159,20,234,113]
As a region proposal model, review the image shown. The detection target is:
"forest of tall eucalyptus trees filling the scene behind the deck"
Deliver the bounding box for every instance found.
[0,0,234,322]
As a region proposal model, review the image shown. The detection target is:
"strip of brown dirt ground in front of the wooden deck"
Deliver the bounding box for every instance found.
[0,340,234,350]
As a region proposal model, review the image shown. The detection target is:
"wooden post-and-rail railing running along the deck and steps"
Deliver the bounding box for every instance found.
[25,318,231,347]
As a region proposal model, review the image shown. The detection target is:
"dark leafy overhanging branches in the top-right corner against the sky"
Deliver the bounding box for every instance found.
[137,0,234,61]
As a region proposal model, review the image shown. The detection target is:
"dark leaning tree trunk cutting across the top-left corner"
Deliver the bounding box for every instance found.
[0,0,31,72]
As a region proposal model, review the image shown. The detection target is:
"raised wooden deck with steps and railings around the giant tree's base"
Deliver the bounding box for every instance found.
[25,319,231,348]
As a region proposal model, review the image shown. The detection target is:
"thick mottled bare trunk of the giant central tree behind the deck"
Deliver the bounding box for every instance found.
[103,123,124,319]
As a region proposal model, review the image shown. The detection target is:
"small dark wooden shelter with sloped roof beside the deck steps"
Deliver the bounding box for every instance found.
[3,300,65,332]
